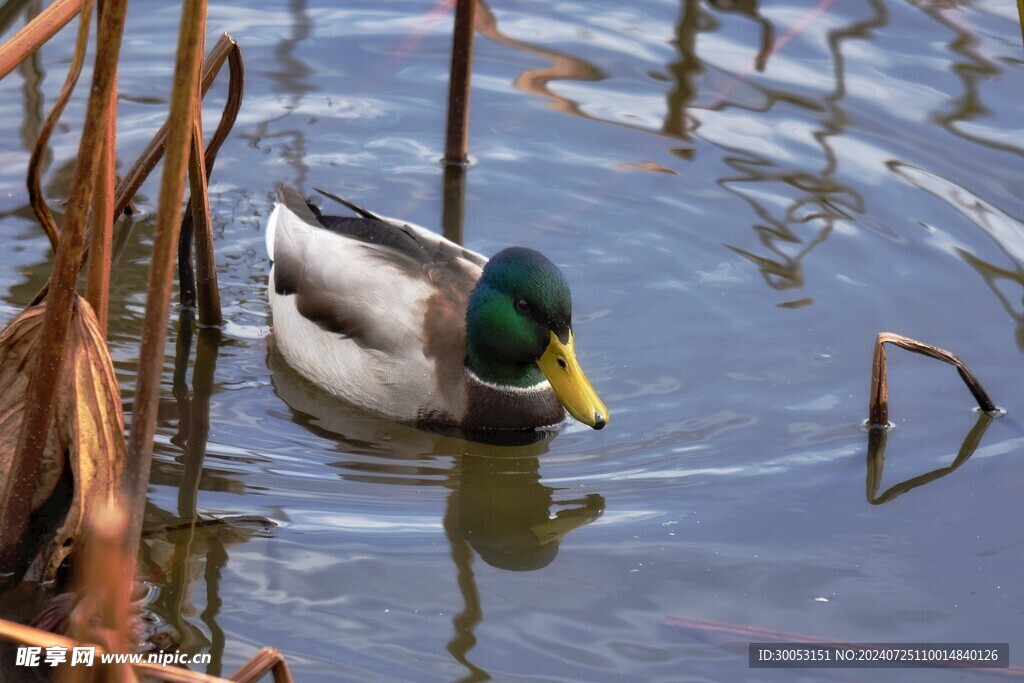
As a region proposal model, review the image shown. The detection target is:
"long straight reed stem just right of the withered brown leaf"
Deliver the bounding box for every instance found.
[125,0,206,590]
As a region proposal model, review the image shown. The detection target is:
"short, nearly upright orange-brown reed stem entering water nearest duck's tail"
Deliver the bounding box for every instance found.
[188,90,223,328]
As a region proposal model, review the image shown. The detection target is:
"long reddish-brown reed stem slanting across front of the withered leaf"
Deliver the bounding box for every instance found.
[0,0,126,566]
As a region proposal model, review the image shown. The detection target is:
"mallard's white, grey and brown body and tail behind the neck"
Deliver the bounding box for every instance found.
[267,189,486,420]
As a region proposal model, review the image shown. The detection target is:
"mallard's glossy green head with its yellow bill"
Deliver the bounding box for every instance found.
[466,247,609,429]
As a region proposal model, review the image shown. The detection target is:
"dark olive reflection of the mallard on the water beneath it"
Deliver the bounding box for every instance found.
[269,349,604,570]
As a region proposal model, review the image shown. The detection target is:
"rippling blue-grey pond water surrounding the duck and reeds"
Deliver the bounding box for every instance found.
[0,0,1024,681]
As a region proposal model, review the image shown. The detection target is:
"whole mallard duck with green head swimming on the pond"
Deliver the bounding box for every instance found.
[266,189,608,430]
